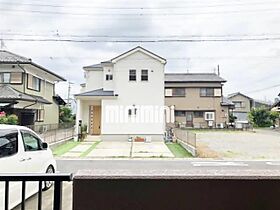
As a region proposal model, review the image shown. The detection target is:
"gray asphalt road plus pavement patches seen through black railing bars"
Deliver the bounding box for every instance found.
[15,159,280,210]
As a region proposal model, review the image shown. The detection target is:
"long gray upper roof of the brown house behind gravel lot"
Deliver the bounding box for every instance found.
[165,73,226,83]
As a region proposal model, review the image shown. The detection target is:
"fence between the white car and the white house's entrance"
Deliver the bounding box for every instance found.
[27,123,75,144]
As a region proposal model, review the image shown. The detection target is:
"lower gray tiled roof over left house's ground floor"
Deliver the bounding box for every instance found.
[0,85,51,104]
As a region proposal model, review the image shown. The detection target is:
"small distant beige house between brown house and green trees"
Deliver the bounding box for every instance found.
[227,92,254,121]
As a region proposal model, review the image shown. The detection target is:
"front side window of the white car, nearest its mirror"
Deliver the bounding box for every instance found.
[21,131,42,151]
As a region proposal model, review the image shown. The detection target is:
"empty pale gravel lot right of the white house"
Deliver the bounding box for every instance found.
[197,130,280,160]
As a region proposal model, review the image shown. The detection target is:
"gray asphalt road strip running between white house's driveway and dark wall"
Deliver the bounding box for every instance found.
[57,159,280,173]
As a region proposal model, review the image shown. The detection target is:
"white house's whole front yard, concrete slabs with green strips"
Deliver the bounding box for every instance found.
[53,141,192,158]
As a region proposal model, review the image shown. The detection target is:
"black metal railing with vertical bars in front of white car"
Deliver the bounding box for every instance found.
[0,174,73,210]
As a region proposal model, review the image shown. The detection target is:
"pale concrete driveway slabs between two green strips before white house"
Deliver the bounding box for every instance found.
[87,141,174,158]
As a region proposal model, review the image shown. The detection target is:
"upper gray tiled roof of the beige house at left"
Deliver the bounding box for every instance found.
[0,50,66,81]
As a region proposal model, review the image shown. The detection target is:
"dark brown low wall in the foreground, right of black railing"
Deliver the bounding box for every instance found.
[73,171,280,210]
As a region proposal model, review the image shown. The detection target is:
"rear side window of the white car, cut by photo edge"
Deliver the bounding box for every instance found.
[0,129,18,158]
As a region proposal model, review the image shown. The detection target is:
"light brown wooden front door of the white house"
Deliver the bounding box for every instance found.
[90,106,101,135]
